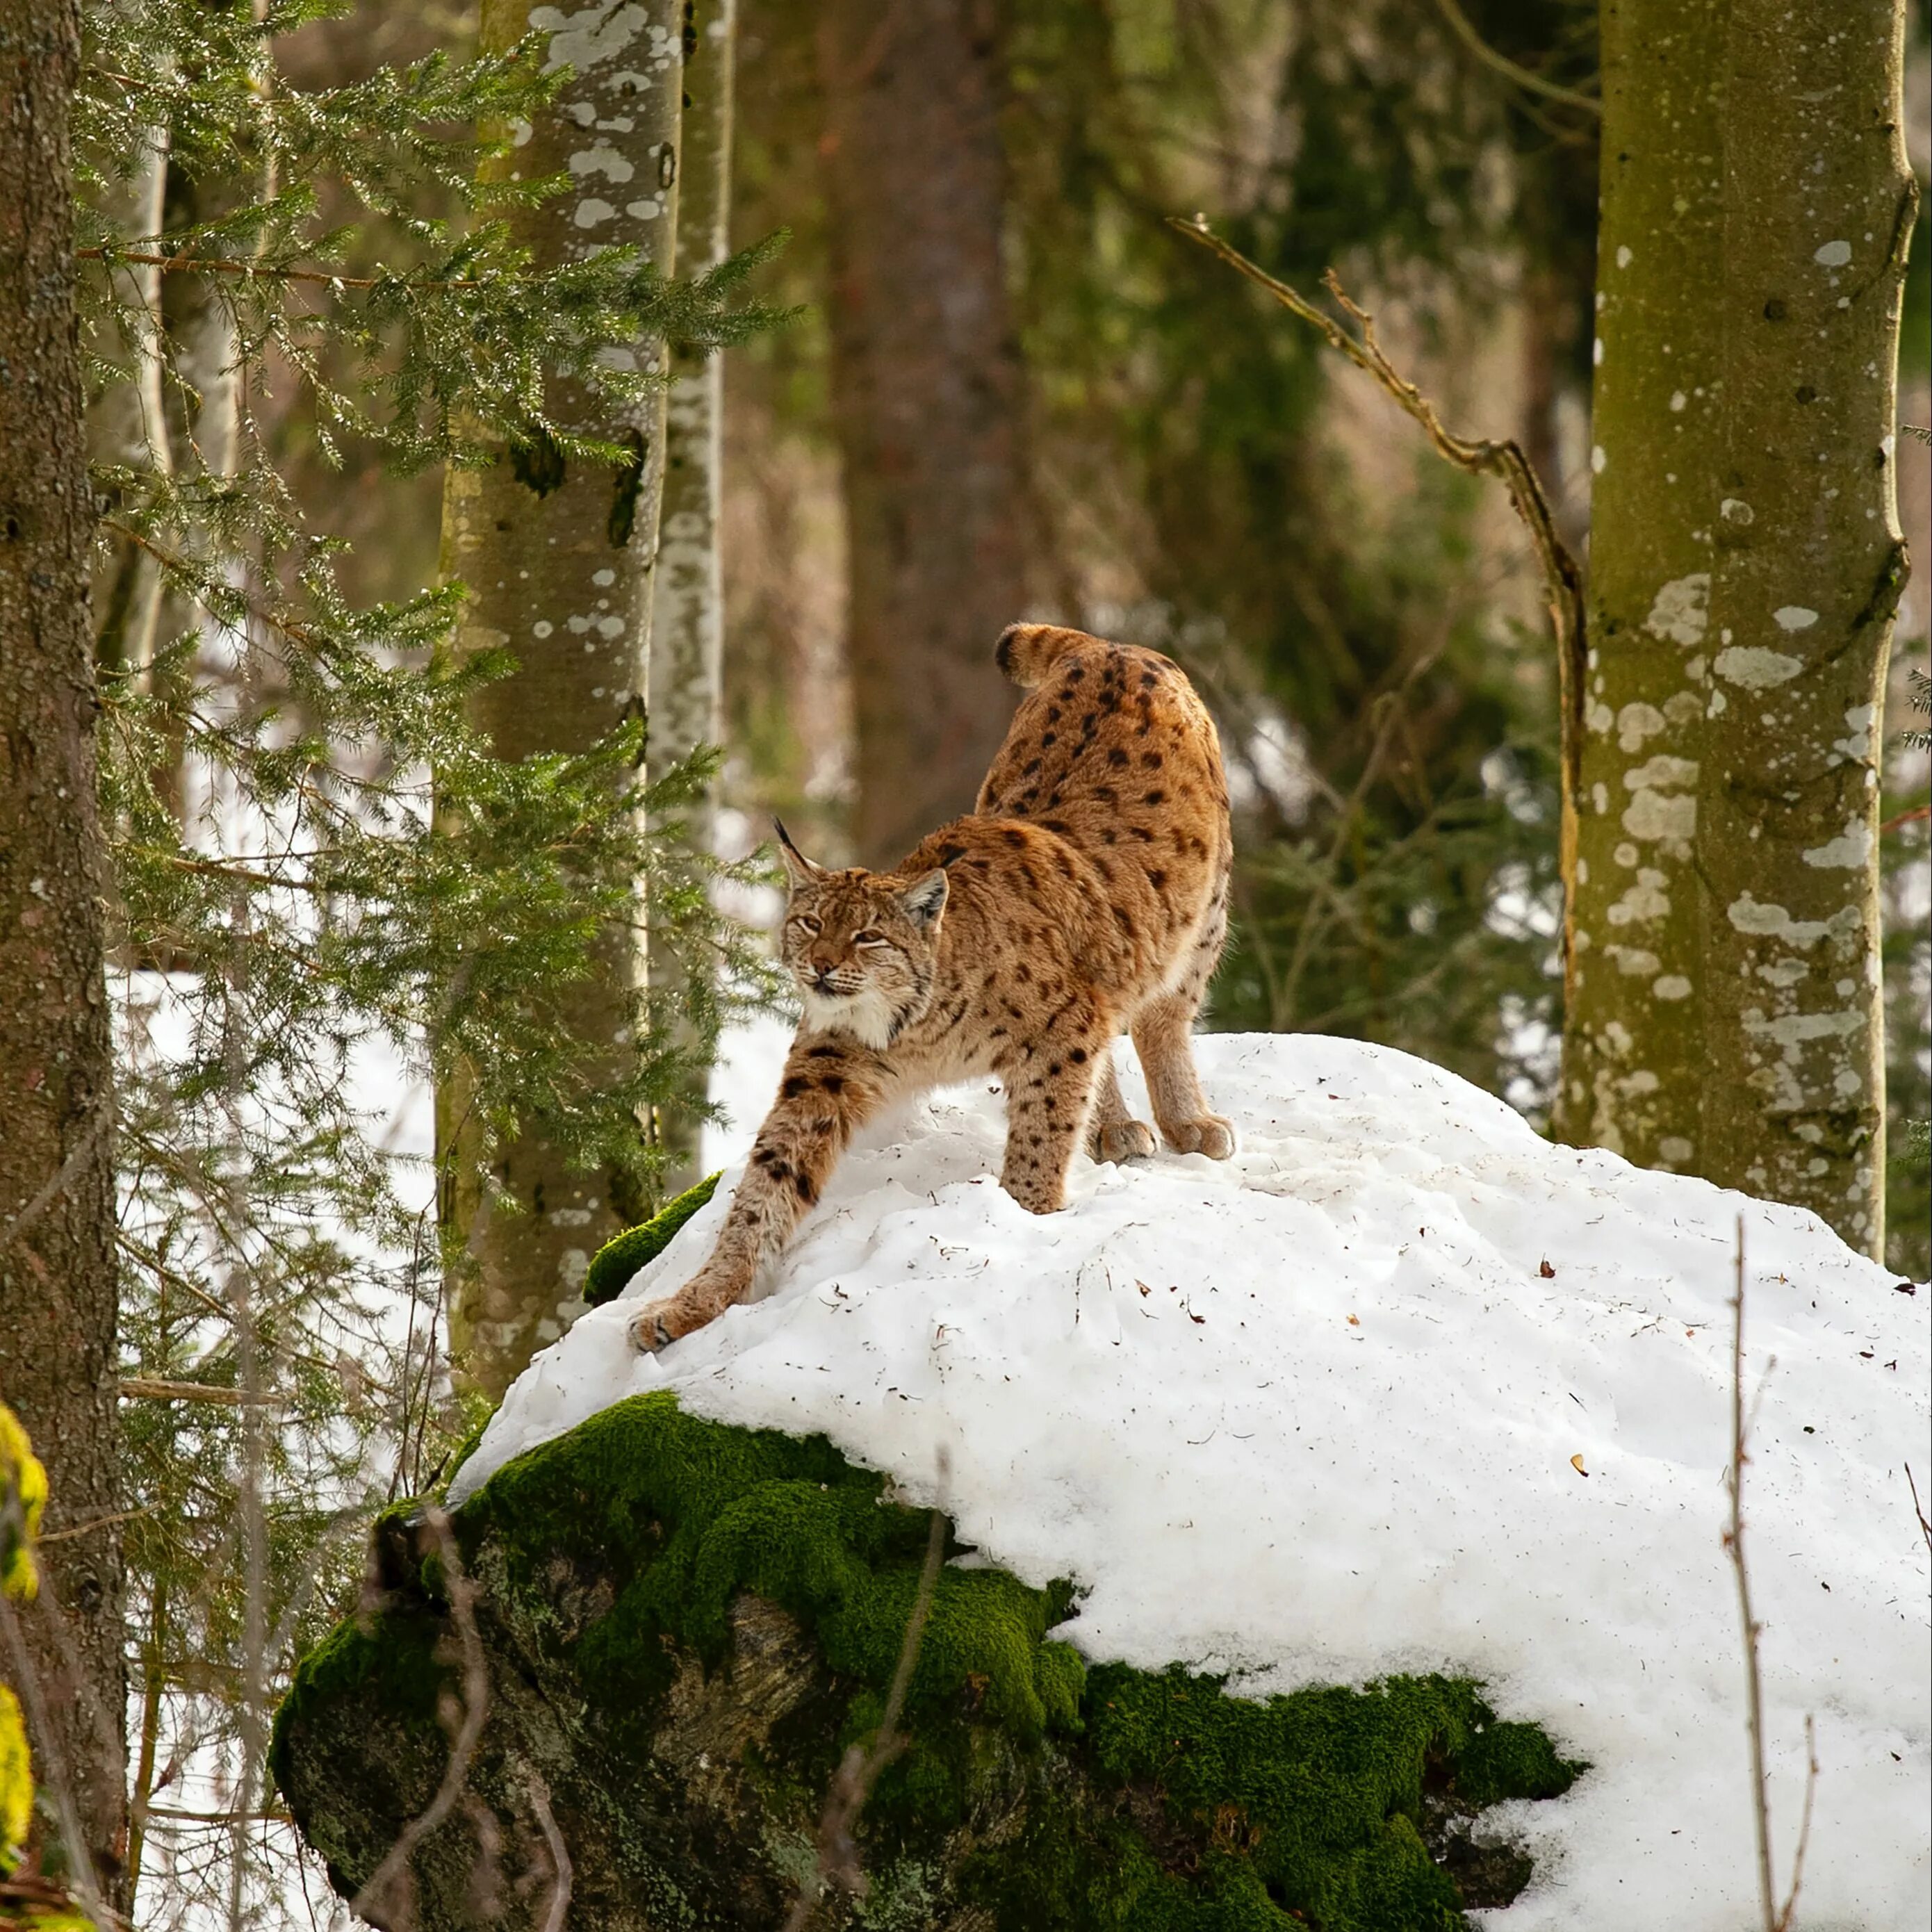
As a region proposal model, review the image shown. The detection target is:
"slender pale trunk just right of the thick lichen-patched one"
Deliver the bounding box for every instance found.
[646,0,738,1200]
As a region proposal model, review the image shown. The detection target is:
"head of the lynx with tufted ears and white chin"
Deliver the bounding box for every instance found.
[773,819,947,1053]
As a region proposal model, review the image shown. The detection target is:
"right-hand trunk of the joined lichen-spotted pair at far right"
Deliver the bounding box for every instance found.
[1696,0,1917,1260]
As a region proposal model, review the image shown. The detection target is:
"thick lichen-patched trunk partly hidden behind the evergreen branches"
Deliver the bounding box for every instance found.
[436,0,684,1397]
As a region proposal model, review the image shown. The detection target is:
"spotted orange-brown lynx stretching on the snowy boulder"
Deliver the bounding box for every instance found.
[630,624,1234,1350]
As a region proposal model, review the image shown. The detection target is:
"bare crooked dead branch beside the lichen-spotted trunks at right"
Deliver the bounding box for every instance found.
[1169,215,1586,988]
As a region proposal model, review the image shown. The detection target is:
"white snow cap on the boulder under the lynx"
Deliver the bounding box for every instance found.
[458,1032,1932,1932]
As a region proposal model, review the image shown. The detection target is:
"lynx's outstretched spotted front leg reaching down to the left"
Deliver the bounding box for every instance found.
[630,1033,894,1354]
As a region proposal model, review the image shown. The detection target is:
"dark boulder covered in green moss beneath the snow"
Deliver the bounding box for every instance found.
[270,1393,1580,1932]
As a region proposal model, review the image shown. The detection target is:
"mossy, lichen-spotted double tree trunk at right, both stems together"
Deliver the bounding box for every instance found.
[1557,0,1913,1252]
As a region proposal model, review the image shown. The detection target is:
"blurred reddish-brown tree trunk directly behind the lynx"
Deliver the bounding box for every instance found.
[819,0,1026,864]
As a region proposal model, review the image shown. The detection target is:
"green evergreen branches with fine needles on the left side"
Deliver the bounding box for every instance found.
[75,0,771,1922]
